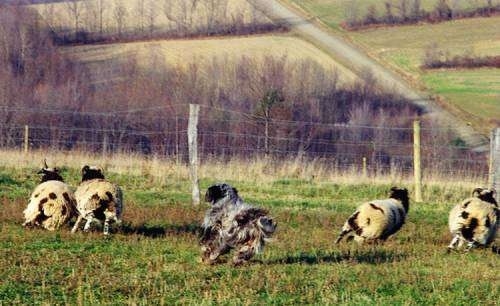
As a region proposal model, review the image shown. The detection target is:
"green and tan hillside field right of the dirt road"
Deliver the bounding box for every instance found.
[289,0,500,133]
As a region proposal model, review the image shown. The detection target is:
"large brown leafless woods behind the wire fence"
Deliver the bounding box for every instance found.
[0,4,482,173]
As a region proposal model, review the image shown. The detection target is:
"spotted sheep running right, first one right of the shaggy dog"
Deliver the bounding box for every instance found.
[336,187,410,243]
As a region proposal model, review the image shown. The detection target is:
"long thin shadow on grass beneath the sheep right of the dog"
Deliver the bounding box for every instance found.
[263,249,407,265]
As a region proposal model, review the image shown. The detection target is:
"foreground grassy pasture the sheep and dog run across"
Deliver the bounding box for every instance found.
[0,152,500,305]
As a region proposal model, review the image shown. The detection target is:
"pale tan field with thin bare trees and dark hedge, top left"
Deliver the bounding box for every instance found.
[20,0,287,45]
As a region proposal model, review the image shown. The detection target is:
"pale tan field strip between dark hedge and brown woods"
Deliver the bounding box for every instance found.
[63,35,354,85]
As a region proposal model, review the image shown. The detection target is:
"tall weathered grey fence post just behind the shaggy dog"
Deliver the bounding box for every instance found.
[188,104,200,205]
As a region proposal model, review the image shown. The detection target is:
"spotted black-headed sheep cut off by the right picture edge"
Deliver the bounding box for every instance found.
[448,188,500,251]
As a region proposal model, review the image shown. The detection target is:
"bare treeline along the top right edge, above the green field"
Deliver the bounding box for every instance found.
[343,0,500,30]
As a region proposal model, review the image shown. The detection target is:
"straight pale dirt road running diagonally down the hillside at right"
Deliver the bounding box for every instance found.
[249,0,488,151]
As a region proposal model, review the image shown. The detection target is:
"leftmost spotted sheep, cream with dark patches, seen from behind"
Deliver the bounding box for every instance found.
[23,162,76,231]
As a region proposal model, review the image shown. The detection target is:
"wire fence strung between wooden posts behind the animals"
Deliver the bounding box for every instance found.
[0,105,492,179]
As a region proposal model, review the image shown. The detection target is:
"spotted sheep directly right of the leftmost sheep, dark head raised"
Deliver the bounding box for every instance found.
[71,166,123,235]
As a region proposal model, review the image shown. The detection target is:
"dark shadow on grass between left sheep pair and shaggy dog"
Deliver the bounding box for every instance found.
[119,223,201,238]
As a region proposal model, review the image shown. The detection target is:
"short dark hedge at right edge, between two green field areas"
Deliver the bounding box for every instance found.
[422,44,500,69]
